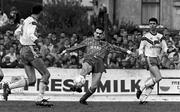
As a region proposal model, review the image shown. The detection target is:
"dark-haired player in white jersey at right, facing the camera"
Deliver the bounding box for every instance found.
[136,18,168,104]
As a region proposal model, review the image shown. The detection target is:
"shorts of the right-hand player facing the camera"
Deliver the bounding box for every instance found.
[146,57,161,70]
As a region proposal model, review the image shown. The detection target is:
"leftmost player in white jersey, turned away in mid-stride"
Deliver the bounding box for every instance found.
[3,5,52,106]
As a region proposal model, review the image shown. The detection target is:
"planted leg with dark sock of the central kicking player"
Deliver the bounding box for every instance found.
[80,73,102,105]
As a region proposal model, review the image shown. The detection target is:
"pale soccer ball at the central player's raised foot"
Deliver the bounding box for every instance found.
[74,75,86,87]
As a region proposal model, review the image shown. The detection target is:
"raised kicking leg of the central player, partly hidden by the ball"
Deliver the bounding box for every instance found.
[70,62,92,92]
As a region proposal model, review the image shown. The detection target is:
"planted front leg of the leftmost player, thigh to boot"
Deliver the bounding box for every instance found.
[31,58,53,106]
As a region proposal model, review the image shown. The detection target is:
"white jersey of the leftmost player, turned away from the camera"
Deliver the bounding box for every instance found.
[15,16,38,45]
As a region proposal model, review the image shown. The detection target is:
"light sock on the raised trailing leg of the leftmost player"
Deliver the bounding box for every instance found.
[9,78,29,89]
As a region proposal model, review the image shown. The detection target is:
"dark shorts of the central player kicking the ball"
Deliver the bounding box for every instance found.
[84,57,106,73]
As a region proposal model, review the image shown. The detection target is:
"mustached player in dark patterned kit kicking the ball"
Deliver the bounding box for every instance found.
[63,27,133,105]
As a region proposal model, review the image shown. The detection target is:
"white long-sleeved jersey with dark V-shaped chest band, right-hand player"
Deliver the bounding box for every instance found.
[139,32,168,57]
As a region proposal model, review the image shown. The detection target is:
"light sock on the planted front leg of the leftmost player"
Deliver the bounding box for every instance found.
[37,81,46,101]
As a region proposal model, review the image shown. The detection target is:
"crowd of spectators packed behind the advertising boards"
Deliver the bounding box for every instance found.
[0,6,180,69]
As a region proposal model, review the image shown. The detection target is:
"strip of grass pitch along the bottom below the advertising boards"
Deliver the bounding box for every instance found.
[0,101,180,112]
